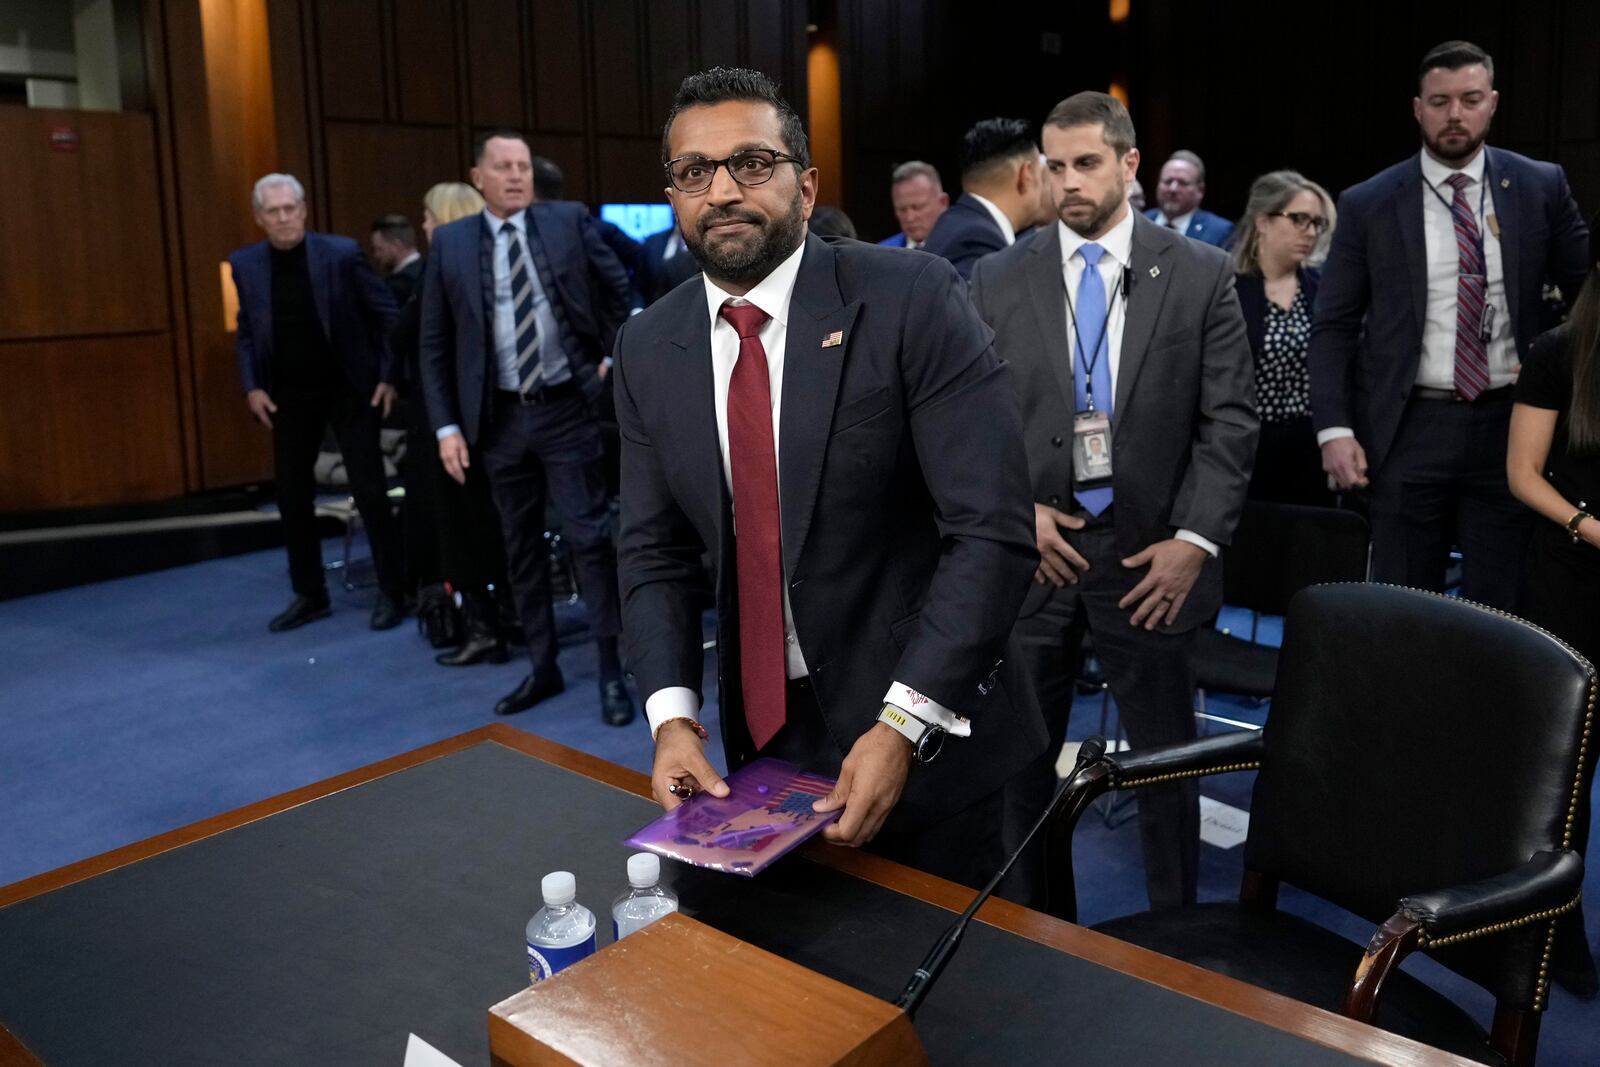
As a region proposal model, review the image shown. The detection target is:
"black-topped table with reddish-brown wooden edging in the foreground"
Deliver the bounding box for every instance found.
[0,726,1462,1067]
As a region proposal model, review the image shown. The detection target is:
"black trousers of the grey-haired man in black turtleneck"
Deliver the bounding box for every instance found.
[272,386,405,600]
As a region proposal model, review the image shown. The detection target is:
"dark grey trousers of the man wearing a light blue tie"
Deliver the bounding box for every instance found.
[1005,509,1200,907]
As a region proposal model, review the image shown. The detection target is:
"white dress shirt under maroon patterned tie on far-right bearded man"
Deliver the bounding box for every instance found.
[1317,147,1517,445]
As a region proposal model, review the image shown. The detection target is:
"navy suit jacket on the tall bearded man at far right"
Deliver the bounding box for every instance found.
[1310,149,1589,470]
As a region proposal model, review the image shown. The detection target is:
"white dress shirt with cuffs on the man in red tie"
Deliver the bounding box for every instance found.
[645,243,971,737]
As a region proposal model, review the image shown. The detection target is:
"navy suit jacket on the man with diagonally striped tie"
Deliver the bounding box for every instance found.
[421,200,627,445]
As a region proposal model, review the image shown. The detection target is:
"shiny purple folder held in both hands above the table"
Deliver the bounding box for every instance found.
[624,758,840,878]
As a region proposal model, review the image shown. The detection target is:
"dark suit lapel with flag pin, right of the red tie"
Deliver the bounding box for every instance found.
[778,237,861,577]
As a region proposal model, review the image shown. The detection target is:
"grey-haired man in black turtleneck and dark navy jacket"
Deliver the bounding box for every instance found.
[227,174,405,632]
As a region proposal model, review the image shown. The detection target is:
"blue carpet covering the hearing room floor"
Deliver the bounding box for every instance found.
[0,556,1600,1065]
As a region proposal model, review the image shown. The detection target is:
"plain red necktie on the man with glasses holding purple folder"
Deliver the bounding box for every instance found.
[722,304,787,749]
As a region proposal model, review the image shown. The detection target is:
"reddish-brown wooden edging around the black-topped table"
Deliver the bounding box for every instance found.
[0,723,1472,1067]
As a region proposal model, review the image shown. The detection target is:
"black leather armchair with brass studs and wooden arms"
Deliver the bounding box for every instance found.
[1046,584,1600,1064]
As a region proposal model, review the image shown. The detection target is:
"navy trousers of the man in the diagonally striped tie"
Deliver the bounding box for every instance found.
[483,382,622,670]
